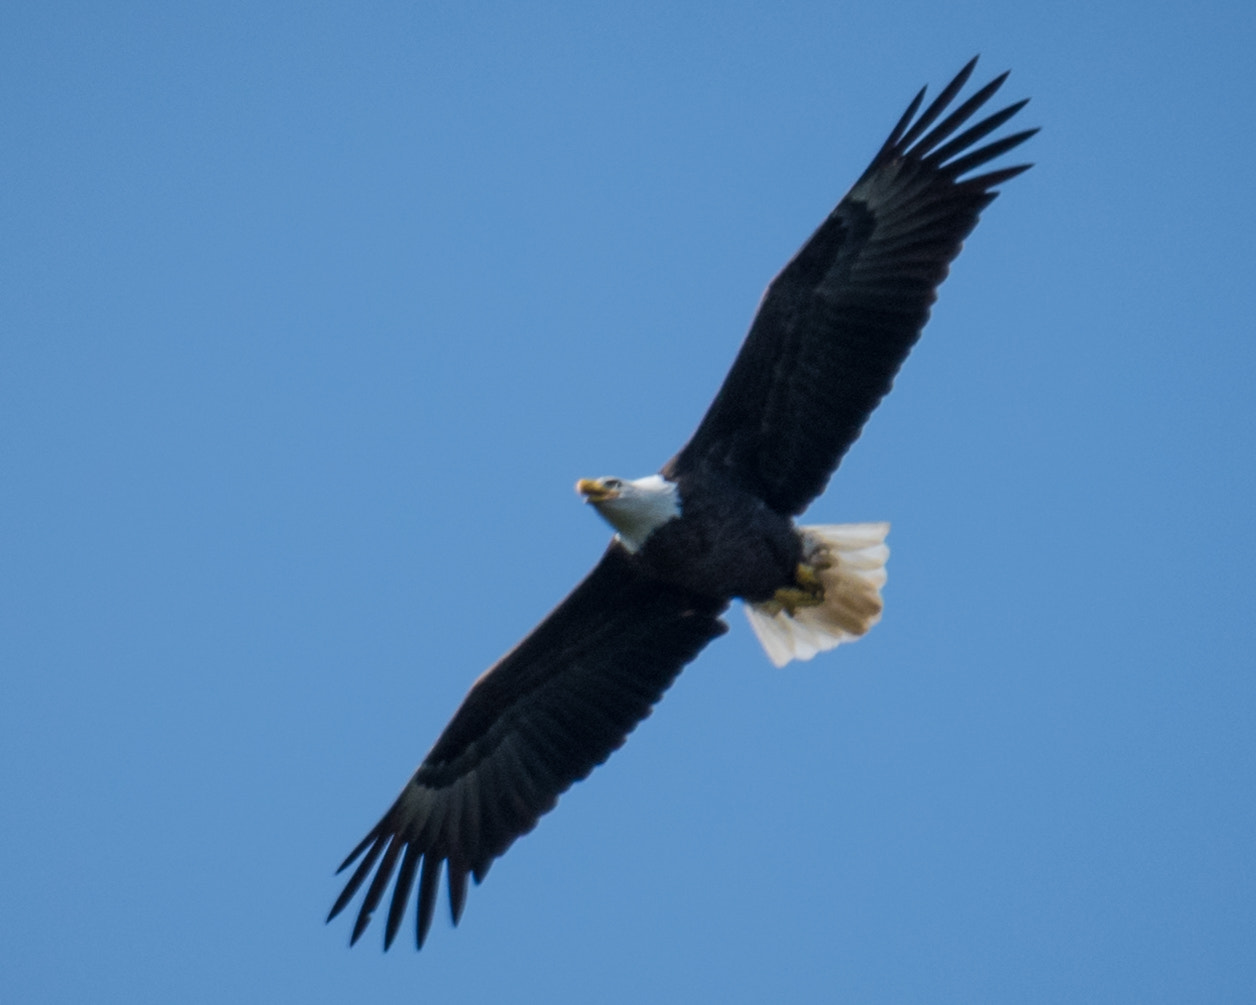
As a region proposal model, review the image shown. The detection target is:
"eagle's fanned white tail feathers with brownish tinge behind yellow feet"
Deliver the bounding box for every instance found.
[746,524,889,667]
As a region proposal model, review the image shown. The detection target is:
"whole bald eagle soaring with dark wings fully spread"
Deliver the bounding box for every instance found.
[328,59,1036,948]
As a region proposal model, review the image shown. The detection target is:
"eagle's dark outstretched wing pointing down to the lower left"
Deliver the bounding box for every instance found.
[328,544,727,948]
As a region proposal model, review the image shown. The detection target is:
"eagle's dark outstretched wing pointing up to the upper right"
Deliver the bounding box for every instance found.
[663,59,1037,515]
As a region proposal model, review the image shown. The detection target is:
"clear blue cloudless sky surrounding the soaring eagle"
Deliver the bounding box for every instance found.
[0,0,1256,1002]
